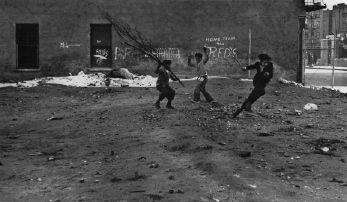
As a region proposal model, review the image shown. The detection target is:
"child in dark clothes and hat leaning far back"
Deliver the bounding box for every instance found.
[233,54,273,118]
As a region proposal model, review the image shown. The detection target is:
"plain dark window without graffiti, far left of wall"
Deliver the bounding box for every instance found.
[16,24,39,69]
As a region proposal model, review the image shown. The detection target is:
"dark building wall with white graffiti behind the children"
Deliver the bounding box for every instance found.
[0,0,302,78]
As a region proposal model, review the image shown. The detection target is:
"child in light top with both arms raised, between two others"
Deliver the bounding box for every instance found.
[188,47,213,103]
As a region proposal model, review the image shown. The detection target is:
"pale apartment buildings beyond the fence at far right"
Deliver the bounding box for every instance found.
[304,4,347,67]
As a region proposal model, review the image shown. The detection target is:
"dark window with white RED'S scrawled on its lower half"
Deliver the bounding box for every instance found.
[90,24,112,67]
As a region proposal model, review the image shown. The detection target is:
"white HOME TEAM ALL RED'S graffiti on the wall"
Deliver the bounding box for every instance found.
[205,36,237,58]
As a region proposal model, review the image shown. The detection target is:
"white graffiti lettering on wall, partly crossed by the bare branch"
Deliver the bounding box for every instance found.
[115,47,181,60]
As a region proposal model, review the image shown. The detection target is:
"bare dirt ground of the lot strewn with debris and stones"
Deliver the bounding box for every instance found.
[0,78,347,202]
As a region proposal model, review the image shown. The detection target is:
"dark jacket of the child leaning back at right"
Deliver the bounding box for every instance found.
[247,62,274,87]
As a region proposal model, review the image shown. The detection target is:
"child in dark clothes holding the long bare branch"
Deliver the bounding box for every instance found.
[154,60,178,109]
